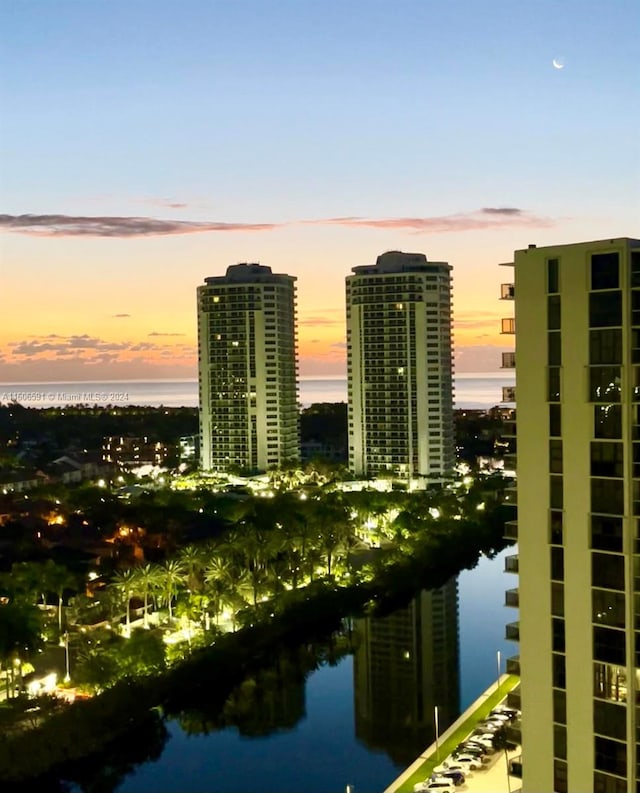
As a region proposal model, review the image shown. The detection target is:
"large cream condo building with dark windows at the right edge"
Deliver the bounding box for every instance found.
[503,239,640,793]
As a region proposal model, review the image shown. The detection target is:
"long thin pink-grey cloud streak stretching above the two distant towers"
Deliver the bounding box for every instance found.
[0,207,555,238]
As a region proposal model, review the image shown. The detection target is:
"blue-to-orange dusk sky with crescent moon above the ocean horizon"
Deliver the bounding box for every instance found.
[0,0,640,383]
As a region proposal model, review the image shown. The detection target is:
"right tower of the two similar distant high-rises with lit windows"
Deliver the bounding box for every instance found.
[346,251,455,487]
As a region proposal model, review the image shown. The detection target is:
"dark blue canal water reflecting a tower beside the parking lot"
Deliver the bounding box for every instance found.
[60,548,516,793]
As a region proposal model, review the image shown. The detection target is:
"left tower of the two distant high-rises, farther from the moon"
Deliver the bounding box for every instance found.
[198,264,299,471]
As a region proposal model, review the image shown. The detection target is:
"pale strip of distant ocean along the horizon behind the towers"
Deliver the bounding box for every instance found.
[0,370,515,410]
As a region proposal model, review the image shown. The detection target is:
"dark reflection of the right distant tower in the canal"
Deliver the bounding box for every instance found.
[354,579,460,764]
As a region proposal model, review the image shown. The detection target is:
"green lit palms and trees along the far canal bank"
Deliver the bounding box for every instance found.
[0,468,507,779]
